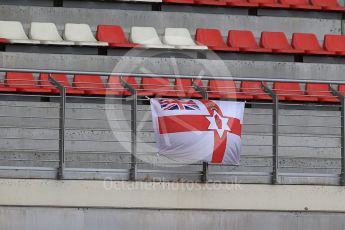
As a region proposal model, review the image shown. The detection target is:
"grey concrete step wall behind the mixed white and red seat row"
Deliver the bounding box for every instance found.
[0,5,341,37]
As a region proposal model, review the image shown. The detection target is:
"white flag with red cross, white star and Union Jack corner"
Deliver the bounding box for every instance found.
[151,98,245,165]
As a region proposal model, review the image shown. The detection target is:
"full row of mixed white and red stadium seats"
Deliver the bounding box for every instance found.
[0,21,345,56]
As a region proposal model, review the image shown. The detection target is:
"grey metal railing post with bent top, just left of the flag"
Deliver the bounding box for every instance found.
[121,77,138,181]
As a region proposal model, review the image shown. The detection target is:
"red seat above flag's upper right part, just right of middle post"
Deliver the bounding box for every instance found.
[207,80,253,100]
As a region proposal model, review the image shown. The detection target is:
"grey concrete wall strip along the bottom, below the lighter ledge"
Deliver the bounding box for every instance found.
[0,207,345,230]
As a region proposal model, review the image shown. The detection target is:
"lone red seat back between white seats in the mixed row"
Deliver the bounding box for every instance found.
[96,25,129,44]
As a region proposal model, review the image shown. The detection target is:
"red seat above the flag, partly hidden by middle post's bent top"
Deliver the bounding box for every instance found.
[174,78,202,98]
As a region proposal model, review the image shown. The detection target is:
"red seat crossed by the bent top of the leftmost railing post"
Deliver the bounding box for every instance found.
[38,73,84,94]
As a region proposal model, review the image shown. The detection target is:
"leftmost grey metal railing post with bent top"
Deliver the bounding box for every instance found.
[48,74,66,179]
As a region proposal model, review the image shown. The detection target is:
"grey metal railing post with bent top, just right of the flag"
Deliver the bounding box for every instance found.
[261,82,279,184]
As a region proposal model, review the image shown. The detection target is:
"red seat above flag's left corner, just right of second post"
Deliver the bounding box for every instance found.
[140,77,171,97]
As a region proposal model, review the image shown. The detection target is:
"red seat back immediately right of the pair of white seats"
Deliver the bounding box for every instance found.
[195,28,226,47]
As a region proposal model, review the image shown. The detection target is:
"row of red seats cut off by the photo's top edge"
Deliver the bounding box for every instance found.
[163,0,345,12]
